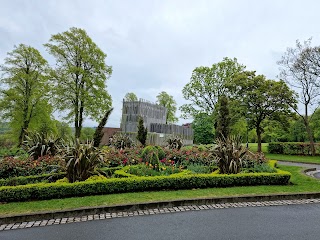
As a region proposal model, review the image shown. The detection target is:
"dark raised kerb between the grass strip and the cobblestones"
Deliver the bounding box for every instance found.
[0,192,320,225]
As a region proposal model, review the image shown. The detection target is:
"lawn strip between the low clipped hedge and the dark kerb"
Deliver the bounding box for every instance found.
[0,166,320,216]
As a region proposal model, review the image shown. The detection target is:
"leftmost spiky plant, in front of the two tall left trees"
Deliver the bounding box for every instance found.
[23,132,62,159]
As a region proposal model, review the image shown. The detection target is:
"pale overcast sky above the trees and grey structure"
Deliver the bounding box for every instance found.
[0,0,320,127]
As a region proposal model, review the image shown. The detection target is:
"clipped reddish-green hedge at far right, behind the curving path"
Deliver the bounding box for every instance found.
[268,142,320,155]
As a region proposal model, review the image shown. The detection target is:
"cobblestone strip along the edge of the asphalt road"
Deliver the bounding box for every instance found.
[0,198,320,232]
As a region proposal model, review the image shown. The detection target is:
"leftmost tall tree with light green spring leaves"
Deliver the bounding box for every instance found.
[0,44,51,145]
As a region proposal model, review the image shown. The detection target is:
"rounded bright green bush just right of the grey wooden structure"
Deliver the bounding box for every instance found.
[192,113,215,144]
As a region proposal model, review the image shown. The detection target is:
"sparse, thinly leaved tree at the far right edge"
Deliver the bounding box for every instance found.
[278,40,320,156]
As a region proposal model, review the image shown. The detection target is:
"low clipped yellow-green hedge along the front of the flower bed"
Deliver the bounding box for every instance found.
[0,161,291,202]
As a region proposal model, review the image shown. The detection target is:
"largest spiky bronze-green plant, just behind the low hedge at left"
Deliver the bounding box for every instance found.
[63,139,103,183]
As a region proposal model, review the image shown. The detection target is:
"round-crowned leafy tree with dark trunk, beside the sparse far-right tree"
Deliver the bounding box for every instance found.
[234,72,296,152]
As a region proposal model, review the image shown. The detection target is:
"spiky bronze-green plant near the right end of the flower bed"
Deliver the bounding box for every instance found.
[212,136,247,174]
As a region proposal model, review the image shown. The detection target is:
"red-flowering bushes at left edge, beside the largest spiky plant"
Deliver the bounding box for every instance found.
[0,156,65,178]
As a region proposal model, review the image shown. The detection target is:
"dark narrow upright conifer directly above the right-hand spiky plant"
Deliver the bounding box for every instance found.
[216,95,230,139]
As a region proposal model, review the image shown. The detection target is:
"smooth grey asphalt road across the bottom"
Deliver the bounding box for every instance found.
[0,204,320,240]
